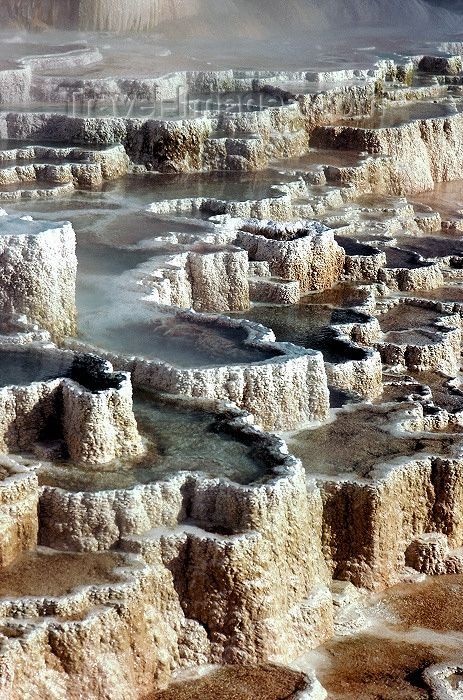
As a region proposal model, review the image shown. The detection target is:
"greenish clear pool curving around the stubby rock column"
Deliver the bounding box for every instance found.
[39,391,268,491]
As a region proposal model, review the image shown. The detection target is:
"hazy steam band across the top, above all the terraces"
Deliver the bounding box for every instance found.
[0,0,463,77]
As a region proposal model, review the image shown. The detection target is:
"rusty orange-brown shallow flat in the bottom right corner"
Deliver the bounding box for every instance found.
[296,575,463,700]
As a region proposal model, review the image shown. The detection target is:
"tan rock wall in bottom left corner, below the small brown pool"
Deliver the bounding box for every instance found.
[0,562,209,700]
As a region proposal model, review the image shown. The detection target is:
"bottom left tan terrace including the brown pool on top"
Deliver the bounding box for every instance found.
[0,548,182,700]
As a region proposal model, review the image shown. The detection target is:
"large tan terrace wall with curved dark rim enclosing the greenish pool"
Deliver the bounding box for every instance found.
[34,406,332,667]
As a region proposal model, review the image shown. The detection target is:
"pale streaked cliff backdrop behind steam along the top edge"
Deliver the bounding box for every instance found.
[0,0,458,38]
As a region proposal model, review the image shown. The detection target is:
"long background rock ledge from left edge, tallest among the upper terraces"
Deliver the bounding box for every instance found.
[0,79,374,172]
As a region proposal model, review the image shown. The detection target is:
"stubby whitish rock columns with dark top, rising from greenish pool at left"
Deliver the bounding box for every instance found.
[0,346,143,464]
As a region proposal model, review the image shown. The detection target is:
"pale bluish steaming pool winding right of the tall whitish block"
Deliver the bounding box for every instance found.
[1,179,284,368]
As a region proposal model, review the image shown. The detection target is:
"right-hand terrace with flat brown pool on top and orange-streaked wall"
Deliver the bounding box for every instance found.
[288,394,463,589]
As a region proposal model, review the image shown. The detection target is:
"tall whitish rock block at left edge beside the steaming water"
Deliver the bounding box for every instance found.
[0,216,77,339]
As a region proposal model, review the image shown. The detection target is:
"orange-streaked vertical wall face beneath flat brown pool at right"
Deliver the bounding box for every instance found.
[322,459,434,589]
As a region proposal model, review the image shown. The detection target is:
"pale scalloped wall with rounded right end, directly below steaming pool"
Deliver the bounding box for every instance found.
[78,312,329,430]
